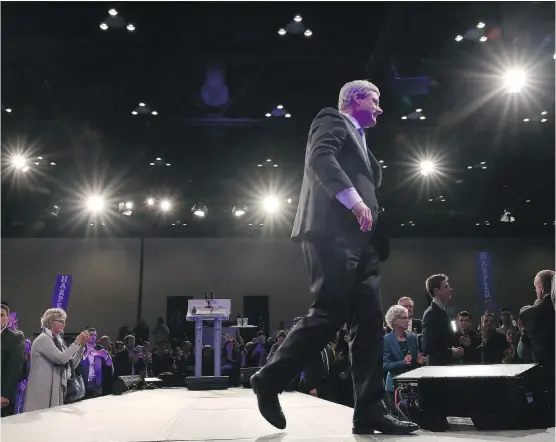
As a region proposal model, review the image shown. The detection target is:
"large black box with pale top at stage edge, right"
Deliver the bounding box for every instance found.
[394,364,547,429]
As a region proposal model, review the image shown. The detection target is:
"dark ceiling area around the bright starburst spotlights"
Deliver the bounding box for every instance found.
[1,2,555,237]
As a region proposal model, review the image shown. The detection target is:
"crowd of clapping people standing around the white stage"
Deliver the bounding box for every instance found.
[1,270,554,430]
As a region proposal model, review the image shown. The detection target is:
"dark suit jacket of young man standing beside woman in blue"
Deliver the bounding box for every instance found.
[422,302,459,365]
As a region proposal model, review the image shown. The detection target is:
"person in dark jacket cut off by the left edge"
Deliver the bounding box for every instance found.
[0,304,25,417]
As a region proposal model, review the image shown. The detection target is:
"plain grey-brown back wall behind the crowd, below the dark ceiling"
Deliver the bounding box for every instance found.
[1,238,554,336]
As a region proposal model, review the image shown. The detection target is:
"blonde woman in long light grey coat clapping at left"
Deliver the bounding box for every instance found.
[24,308,89,411]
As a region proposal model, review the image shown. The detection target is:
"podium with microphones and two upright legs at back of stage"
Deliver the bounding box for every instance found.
[186,308,230,377]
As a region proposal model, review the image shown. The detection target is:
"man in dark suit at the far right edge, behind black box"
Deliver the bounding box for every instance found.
[520,270,556,426]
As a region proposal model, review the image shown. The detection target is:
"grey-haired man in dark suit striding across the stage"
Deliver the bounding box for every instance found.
[251,80,417,434]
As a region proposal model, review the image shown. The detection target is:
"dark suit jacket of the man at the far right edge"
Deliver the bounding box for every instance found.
[519,295,555,376]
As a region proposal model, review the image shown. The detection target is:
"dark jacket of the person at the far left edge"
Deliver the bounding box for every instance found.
[1,328,25,404]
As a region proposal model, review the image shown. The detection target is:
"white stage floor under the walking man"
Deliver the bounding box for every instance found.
[0,388,555,442]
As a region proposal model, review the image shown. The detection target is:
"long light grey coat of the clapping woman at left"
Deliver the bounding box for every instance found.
[24,329,85,411]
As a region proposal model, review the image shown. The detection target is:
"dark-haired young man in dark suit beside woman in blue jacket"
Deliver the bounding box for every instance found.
[423,274,464,365]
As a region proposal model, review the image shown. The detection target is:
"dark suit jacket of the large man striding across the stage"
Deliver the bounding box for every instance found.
[292,107,389,260]
